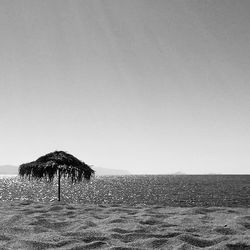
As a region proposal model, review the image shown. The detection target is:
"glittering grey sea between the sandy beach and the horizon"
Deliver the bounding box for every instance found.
[0,175,250,208]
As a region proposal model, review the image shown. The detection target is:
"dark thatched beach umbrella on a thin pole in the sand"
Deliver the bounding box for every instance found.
[19,151,95,201]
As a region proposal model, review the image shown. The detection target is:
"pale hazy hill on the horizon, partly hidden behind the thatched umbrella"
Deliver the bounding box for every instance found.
[0,165,131,176]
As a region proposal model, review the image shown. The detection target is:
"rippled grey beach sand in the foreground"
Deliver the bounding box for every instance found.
[0,201,250,250]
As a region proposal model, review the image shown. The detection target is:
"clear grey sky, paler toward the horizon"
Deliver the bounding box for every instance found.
[0,0,250,174]
